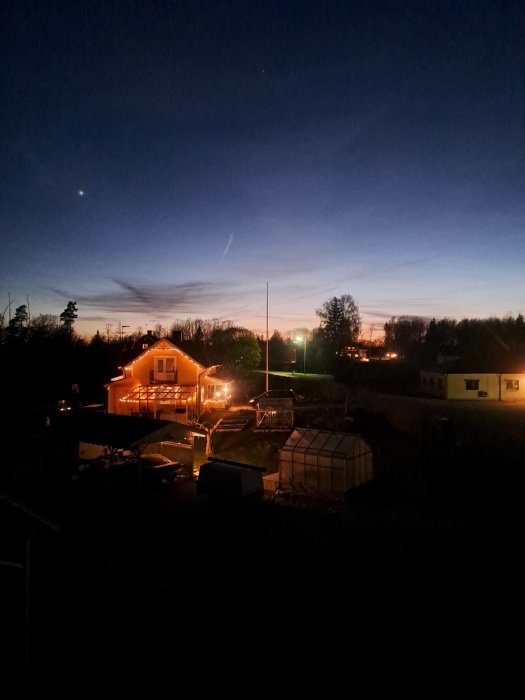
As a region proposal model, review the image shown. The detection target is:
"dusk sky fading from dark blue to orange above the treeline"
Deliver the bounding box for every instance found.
[0,0,525,335]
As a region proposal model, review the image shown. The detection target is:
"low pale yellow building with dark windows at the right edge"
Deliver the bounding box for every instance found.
[421,369,525,401]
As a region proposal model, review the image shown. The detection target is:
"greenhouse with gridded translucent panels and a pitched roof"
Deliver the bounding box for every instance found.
[279,428,374,499]
